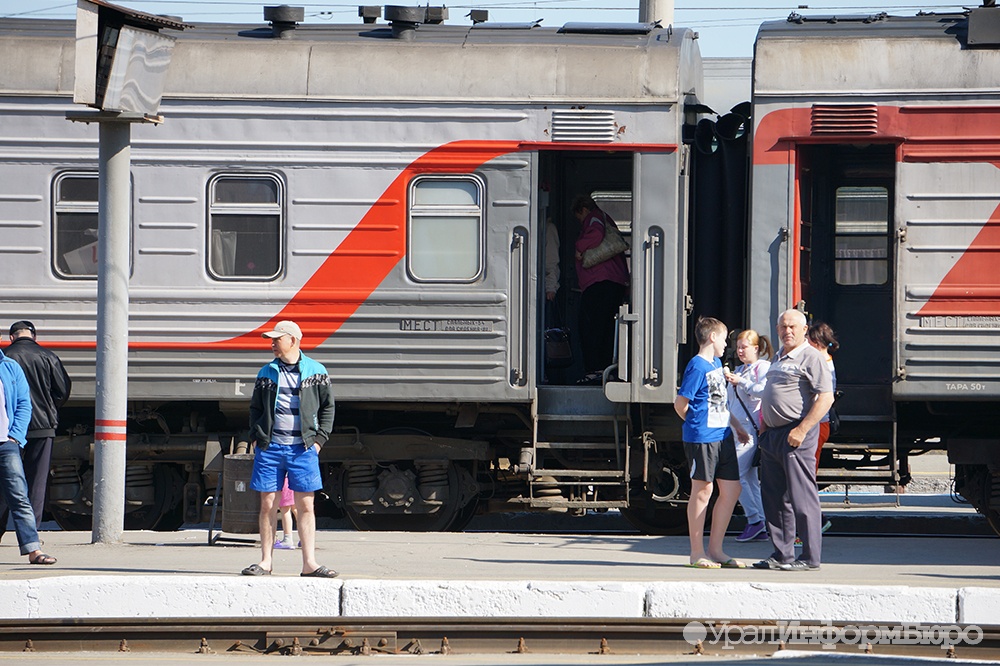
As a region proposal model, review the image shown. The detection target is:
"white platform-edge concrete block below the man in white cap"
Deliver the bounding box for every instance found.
[19,576,343,618]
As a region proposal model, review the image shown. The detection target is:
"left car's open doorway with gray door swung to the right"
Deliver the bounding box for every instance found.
[539,147,687,403]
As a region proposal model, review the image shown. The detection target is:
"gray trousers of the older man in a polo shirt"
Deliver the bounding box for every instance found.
[759,422,823,565]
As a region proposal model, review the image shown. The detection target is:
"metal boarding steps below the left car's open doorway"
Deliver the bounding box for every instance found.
[528,386,631,512]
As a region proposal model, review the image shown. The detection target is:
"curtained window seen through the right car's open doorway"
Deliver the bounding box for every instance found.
[834,187,889,285]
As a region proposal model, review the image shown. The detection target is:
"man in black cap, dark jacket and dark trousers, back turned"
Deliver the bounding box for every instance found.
[0,321,73,535]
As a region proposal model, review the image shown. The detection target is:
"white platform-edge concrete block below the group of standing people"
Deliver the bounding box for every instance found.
[647,573,956,623]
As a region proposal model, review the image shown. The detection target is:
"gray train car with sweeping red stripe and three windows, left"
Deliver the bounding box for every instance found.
[0,11,702,530]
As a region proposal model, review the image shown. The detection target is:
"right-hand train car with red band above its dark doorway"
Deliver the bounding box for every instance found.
[749,6,1000,532]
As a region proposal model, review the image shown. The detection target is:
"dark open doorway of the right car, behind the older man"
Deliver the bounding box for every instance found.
[798,144,896,442]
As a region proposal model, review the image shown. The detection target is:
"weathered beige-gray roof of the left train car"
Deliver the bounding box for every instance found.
[0,19,701,104]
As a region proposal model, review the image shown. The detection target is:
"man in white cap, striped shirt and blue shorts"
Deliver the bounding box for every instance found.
[241,321,337,578]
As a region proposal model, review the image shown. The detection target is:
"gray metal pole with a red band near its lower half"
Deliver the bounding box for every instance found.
[92,122,132,543]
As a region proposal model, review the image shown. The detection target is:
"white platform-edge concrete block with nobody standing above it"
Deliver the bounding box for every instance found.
[342,580,646,618]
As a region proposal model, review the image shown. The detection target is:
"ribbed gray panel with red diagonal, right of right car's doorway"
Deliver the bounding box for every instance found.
[893,163,1000,400]
